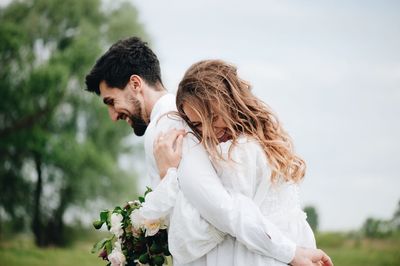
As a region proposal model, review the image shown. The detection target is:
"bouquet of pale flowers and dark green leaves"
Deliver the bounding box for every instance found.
[92,187,171,266]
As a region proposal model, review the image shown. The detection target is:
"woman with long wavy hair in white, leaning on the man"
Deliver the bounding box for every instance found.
[146,60,328,265]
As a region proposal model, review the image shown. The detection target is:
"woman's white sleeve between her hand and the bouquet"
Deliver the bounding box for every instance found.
[140,168,179,220]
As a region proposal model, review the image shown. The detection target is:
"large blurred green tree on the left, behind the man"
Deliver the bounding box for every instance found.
[0,0,145,246]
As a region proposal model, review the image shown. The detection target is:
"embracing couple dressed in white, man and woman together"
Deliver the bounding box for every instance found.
[86,37,333,266]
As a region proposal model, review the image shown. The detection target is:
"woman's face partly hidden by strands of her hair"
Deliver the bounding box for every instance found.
[182,104,231,143]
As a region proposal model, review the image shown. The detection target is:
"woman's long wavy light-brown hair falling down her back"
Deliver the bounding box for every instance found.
[176,60,306,182]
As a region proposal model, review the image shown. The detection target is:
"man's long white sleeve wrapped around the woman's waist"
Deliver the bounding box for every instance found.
[178,134,296,263]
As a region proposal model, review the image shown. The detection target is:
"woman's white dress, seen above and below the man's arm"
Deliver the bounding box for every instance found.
[195,136,316,266]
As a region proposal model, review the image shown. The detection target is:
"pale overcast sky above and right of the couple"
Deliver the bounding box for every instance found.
[133,0,400,230]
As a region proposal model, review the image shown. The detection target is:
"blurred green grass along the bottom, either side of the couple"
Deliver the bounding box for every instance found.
[0,233,400,266]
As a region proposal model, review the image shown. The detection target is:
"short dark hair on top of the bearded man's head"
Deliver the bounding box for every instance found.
[85,37,162,95]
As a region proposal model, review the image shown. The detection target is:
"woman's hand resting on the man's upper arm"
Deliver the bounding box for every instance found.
[153,129,186,179]
